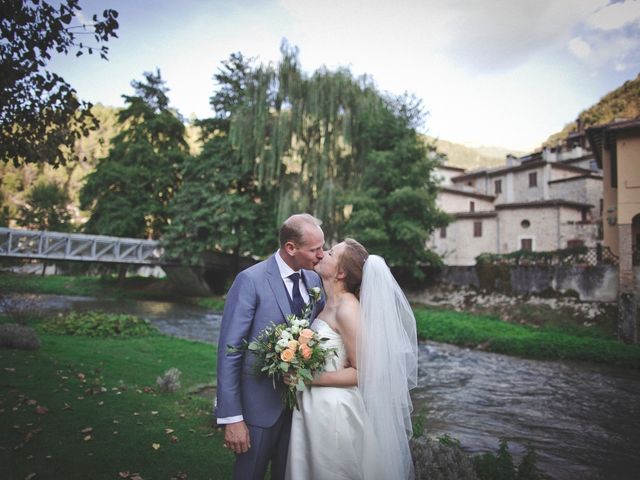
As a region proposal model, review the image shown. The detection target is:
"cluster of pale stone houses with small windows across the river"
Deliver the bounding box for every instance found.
[428,144,602,266]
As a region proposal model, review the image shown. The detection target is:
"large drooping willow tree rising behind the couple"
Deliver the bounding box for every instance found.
[230,44,447,277]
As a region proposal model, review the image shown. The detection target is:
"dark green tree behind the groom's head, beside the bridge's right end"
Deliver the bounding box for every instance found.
[162,134,277,272]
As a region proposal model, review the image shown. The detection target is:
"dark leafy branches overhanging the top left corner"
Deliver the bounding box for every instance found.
[0,0,118,166]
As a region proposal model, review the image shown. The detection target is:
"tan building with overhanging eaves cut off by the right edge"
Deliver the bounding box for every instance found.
[587,119,640,343]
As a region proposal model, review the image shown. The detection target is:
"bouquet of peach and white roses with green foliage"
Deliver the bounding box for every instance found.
[228,287,335,410]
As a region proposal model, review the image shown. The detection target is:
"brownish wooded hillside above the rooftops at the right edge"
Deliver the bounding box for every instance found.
[544,74,640,146]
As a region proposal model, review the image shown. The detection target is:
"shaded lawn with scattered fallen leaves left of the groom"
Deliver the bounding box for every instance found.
[0,334,233,479]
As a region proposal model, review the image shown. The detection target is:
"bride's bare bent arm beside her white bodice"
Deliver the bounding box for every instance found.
[311,297,360,387]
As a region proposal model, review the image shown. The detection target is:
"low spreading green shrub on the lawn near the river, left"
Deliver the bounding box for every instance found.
[41,311,158,338]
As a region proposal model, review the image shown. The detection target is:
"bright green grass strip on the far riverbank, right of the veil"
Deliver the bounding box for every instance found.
[415,308,640,368]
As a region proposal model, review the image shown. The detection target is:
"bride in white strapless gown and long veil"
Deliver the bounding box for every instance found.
[287,239,418,480]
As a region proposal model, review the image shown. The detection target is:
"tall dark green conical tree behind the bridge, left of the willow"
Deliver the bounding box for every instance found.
[80,71,189,239]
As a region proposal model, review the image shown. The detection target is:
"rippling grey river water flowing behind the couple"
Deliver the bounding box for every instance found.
[1,295,640,480]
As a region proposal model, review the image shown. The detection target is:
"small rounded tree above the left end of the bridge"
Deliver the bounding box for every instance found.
[17,182,71,232]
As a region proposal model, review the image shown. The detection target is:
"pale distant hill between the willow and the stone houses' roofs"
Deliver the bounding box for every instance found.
[425,136,528,170]
